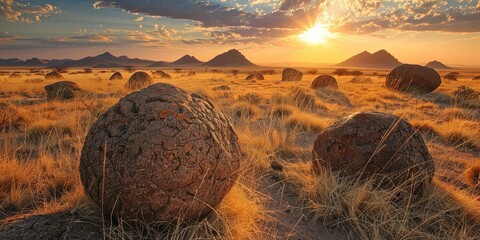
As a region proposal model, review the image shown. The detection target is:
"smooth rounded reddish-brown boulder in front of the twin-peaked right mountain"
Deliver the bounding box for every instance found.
[385,64,442,93]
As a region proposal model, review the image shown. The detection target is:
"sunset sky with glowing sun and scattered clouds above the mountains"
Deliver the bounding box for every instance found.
[0,0,480,65]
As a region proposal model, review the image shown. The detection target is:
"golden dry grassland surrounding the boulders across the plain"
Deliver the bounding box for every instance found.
[0,69,480,239]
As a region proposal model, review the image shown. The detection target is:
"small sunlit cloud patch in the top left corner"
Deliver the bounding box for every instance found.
[0,0,61,23]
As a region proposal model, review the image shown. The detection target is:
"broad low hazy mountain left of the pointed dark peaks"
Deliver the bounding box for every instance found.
[57,52,154,67]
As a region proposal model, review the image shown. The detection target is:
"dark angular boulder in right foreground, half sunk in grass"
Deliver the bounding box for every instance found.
[313,112,435,191]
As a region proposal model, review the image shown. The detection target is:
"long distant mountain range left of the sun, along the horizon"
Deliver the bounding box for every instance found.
[0,49,256,68]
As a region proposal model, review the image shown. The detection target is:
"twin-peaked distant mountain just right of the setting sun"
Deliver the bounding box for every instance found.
[337,50,402,68]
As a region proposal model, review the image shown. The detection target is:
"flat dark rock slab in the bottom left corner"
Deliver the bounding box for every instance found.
[0,212,103,240]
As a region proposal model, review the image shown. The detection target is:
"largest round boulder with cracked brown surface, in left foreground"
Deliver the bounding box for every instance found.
[80,83,241,224]
